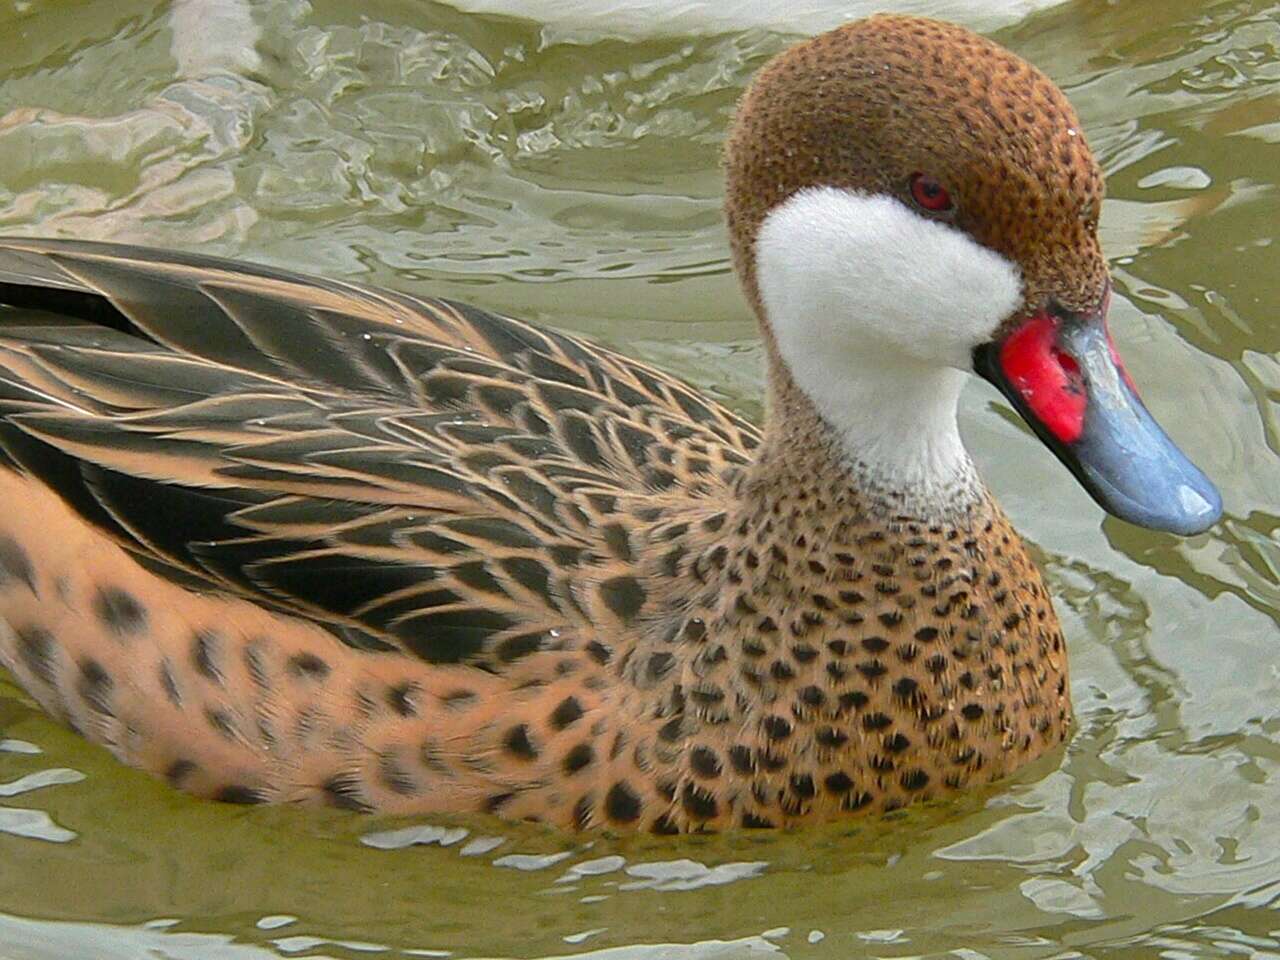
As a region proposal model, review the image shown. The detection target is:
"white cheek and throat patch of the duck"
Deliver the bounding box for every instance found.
[755,187,1021,517]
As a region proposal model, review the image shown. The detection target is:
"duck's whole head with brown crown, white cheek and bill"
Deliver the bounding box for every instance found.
[726,17,1221,534]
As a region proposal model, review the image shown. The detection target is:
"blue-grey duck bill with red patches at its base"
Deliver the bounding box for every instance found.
[974,297,1222,536]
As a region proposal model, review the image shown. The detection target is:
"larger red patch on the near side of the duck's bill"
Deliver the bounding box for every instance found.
[1000,320,1088,443]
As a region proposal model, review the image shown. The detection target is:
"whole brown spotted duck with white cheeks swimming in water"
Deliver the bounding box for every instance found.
[0,15,1222,833]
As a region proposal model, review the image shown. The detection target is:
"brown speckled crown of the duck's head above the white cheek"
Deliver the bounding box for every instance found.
[726,15,1106,327]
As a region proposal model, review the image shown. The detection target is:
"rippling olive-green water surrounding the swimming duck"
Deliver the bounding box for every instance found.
[0,0,1280,960]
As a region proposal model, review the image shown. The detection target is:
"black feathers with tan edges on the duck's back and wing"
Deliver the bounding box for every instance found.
[0,239,759,671]
